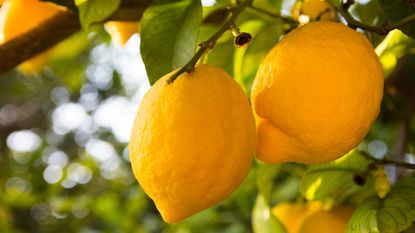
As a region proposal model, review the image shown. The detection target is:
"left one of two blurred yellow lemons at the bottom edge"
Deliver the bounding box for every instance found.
[272,202,322,233]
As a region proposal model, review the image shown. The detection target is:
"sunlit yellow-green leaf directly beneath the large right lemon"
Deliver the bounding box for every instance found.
[300,150,368,200]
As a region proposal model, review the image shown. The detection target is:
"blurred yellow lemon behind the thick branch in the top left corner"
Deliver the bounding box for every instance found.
[0,0,60,74]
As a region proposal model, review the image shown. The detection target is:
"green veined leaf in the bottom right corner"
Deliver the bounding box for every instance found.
[347,177,415,233]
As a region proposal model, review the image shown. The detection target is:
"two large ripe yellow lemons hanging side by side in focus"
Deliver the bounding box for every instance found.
[130,19,383,223]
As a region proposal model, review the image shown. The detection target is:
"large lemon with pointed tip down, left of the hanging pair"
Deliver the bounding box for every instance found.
[129,65,255,223]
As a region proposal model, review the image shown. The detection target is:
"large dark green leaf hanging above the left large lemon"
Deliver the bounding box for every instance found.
[141,0,202,84]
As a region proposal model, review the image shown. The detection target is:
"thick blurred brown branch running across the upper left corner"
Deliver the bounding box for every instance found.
[0,0,150,75]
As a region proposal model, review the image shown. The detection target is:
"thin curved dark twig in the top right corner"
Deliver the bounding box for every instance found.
[334,0,415,35]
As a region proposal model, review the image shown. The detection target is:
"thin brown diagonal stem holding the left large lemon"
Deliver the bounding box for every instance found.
[167,0,253,84]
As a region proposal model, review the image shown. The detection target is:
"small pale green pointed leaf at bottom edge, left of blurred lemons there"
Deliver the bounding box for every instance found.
[252,195,286,233]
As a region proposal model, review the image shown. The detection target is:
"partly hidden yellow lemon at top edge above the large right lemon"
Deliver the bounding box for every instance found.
[292,0,337,21]
